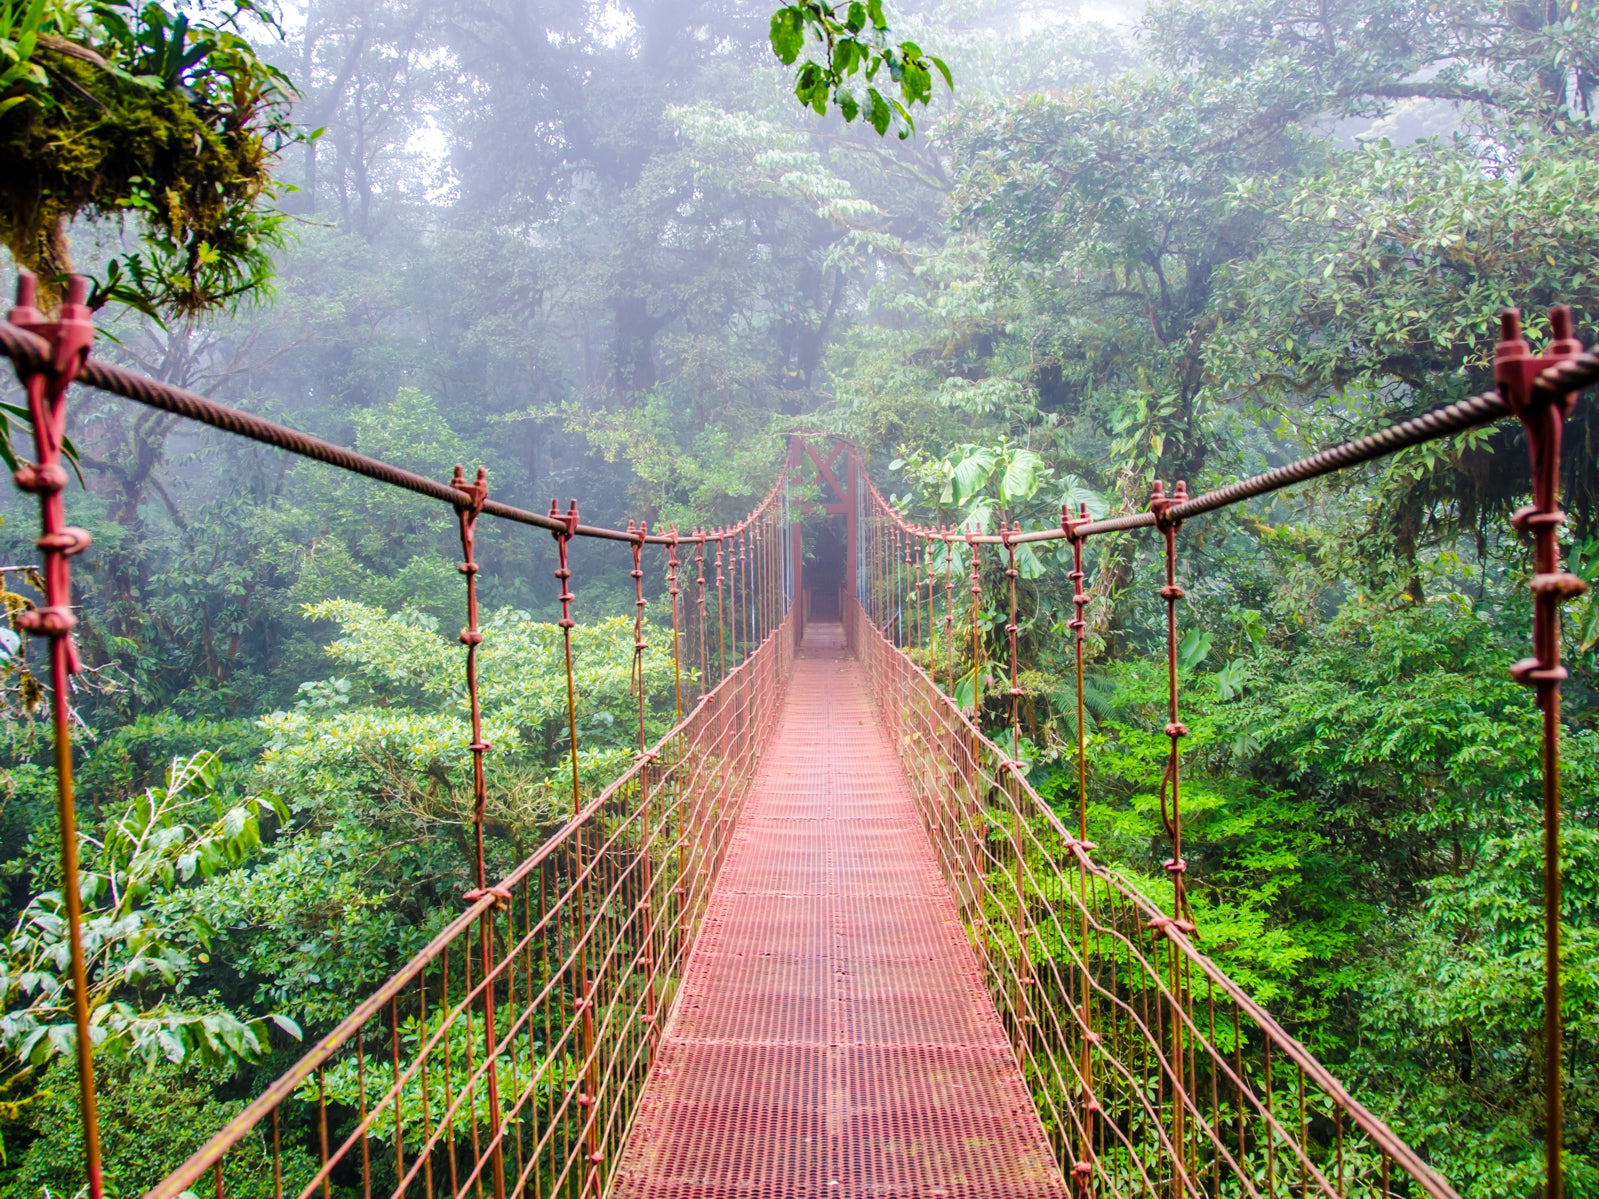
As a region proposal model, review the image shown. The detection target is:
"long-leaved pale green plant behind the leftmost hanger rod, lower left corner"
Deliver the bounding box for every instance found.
[0,750,301,1186]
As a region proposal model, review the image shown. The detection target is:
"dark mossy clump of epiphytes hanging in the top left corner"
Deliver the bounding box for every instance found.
[0,0,294,317]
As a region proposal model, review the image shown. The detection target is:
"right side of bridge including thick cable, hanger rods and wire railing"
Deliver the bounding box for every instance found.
[847,309,1599,1199]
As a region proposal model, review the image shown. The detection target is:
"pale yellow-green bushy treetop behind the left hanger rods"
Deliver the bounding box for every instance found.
[165,600,673,1026]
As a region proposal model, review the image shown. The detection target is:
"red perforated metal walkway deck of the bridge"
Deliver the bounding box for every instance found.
[617,625,1065,1199]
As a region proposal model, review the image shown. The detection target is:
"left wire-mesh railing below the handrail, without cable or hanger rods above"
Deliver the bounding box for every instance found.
[147,612,798,1199]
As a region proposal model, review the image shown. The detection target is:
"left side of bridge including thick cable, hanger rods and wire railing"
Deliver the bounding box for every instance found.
[0,272,800,1199]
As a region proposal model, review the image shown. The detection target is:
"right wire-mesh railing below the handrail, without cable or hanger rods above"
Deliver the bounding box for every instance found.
[849,600,1455,1199]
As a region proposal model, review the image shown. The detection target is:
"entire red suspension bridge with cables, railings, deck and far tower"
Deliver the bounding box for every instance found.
[0,277,1599,1199]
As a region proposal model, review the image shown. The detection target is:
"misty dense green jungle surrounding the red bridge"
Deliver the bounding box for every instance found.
[0,0,1599,1199]
